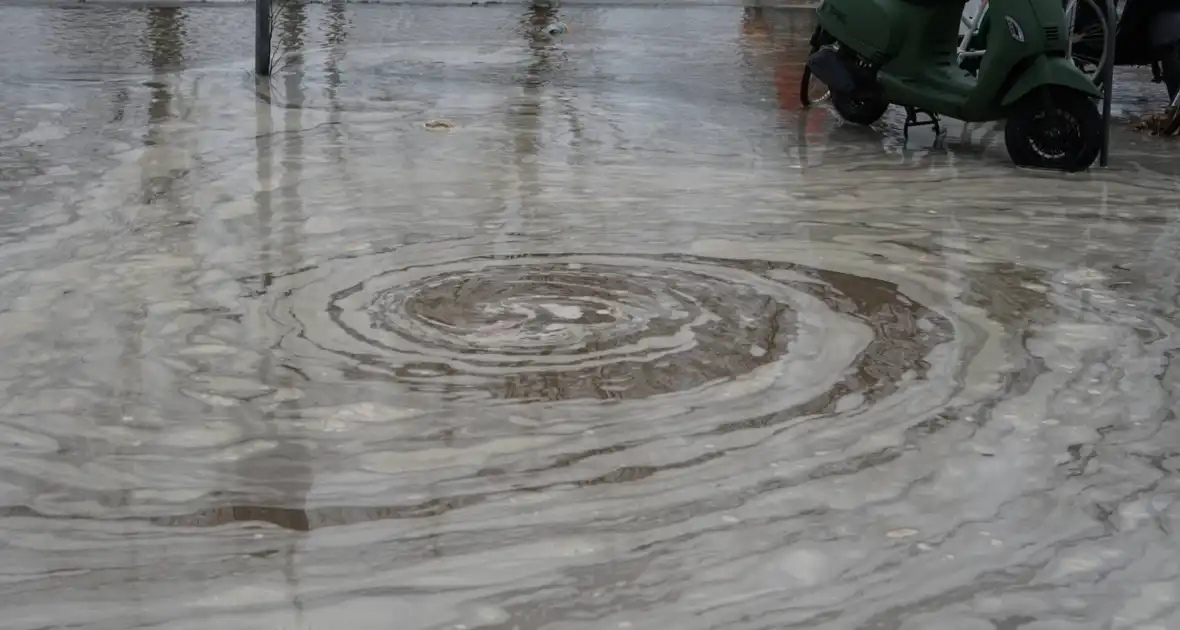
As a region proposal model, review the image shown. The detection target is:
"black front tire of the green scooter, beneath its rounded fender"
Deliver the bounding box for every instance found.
[1004,87,1102,172]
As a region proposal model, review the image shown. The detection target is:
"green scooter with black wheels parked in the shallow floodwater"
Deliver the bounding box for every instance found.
[807,0,1103,171]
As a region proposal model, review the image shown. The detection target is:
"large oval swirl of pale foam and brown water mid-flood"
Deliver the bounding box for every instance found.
[265,252,952,409]
